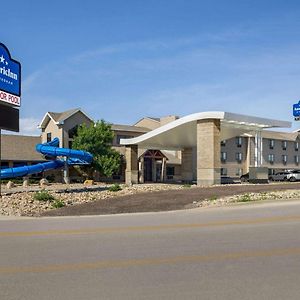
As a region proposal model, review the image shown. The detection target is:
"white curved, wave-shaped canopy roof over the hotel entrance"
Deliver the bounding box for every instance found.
[120,111,291,150]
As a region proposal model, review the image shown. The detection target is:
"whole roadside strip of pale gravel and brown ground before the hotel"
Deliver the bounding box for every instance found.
[0,183,300,216]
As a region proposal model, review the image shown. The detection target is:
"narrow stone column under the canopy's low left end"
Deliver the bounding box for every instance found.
[125,145,139,185]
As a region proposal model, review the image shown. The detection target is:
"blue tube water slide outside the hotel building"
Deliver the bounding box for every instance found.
[0,138,93,179]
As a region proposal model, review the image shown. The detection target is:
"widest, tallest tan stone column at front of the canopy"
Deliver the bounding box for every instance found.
[197,119,221,185]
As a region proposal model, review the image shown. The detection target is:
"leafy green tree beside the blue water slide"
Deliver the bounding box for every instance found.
[72,120,121,177]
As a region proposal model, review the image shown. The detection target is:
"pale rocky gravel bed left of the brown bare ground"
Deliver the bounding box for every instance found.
[0,184,184,216]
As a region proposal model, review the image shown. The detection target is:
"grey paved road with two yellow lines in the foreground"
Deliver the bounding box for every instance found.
[0,201,300,300]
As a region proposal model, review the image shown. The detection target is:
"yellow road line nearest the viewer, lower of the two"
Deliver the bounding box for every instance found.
[0,248,300,275]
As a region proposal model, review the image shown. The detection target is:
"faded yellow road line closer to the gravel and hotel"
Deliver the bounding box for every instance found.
[0,216,300,237]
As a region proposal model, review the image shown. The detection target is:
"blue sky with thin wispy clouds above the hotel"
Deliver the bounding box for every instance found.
[0,0,300,134]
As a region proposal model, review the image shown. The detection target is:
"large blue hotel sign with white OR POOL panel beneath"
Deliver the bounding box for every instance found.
[0,43,21,106]
